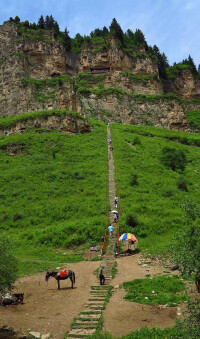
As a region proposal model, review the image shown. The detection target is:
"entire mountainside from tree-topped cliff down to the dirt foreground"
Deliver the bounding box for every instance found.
[0,16,200,339]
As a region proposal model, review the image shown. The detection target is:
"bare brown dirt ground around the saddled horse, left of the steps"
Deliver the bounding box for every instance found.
[0,261,99,339]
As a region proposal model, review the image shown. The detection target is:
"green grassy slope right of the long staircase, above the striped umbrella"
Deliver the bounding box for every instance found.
[111,124,200,255]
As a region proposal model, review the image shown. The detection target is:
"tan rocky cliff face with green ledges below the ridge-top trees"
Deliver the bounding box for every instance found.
[0,23,200,130]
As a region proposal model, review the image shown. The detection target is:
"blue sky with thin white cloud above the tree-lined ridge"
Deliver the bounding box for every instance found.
[0,0,200,66]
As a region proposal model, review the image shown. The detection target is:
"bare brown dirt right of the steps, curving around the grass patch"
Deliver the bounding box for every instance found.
[103,254,180,337]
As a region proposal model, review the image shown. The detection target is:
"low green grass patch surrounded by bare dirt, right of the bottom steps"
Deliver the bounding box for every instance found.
[123,275,188,306]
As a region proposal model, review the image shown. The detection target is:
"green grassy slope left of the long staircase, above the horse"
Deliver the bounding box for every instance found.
[0,122,107,275]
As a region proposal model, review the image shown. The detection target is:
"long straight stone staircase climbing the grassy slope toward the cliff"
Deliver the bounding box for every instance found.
[67,127,117,338]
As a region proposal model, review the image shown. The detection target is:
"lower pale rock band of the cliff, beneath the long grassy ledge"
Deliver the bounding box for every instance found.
[79,94,190,131]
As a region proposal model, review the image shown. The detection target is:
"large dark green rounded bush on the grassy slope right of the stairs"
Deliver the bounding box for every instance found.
[161,147,187,171]
